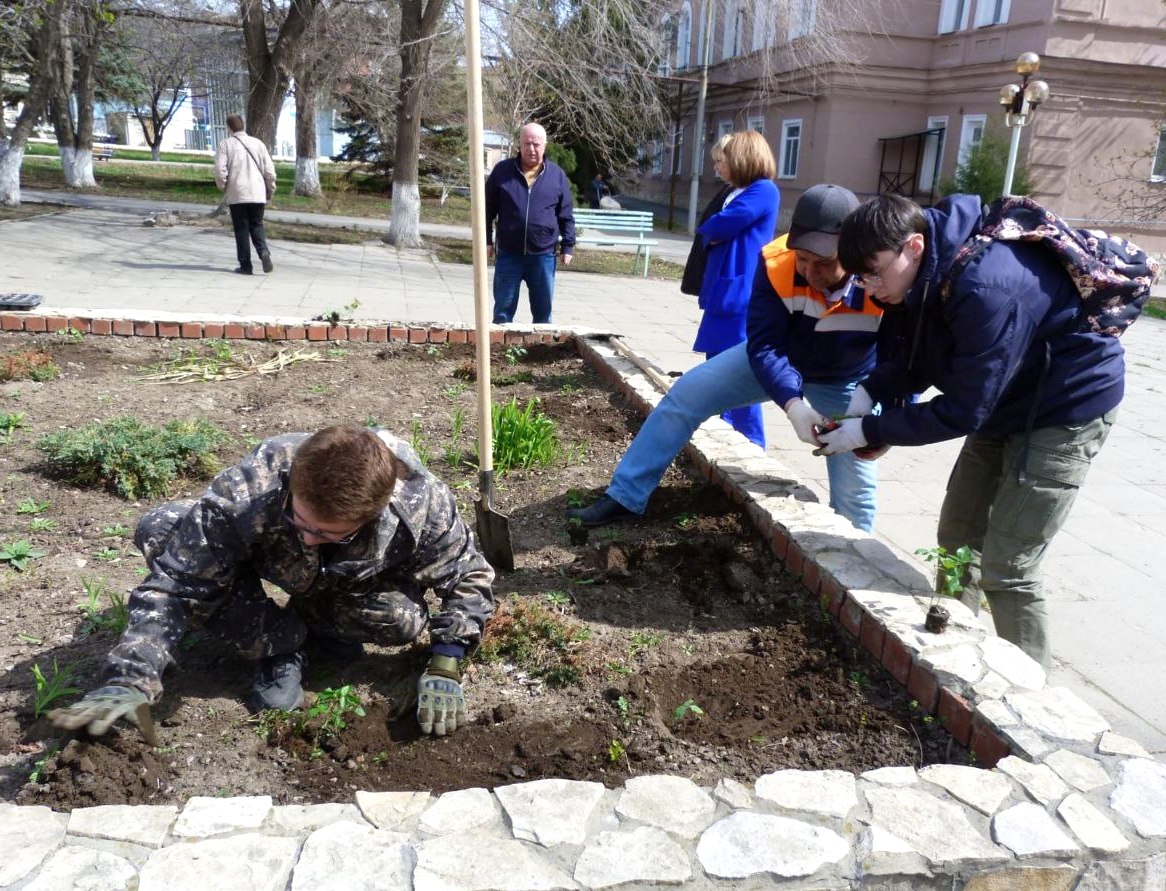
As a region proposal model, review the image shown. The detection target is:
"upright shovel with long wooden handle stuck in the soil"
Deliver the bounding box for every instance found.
[465,0,514,570]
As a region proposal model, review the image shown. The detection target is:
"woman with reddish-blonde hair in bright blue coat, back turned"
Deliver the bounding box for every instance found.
[693,131,781,449]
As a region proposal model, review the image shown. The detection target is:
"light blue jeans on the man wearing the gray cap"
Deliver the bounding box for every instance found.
[607,344,878,532]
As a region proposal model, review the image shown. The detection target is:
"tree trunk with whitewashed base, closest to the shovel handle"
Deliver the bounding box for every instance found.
[385,0,447,247]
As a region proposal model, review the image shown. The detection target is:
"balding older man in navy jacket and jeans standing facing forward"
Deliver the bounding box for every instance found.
[486,124,575,324]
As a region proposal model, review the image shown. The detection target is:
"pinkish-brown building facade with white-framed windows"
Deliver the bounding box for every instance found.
[639,0,1166,253]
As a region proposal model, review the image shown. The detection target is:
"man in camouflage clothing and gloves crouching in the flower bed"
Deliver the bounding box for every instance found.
[52,426,494,736]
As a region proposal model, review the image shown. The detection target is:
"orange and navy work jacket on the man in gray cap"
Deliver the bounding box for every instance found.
[746,236,891,407]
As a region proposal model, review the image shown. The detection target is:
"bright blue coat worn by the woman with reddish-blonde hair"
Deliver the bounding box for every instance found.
[693,180,781,353]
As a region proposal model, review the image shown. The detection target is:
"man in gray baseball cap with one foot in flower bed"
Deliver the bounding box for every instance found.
[567,184,883,532]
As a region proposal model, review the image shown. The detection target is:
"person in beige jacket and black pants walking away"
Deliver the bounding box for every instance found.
[215,114,275,275]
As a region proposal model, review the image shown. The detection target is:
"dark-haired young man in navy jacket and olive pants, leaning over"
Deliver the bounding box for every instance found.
[821,195,1125,668]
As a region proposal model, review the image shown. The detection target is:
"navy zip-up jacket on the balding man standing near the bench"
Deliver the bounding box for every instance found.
[486,157,575,254]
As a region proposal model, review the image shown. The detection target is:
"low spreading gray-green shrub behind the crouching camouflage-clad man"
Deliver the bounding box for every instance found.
[36,418,226,499]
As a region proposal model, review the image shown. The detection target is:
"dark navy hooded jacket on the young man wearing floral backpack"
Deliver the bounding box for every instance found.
[863,195,1125,446]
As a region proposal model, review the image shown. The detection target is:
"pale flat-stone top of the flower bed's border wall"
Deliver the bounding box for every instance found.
[0,315,1166,891]
